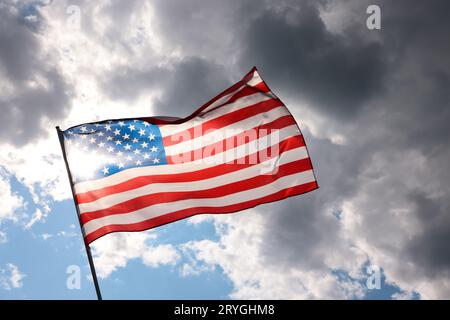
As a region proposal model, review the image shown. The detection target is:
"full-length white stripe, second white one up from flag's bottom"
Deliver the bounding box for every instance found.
[79,147,308,213]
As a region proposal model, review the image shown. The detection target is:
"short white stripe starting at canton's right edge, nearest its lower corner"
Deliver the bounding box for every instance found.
[164,105,289,156]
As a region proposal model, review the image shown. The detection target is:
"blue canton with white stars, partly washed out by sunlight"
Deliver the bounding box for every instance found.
[63,120,167,182]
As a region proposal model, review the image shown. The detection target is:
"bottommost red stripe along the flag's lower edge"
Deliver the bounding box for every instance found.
[85,181,318,244]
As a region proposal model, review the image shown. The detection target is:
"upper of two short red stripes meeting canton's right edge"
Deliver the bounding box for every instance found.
[163,99,283,147]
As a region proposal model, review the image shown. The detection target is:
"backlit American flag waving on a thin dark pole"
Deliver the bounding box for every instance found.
[62,68,318,244]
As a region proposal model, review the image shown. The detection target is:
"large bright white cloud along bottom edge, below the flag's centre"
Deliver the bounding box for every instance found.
[181,209,364,299]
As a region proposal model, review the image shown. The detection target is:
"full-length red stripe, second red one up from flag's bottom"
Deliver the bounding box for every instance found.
[81,159,312,224]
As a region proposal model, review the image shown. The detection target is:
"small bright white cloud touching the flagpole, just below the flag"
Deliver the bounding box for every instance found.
[92,232,180,278]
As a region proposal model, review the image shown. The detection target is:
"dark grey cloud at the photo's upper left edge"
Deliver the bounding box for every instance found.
[0,2,70,145]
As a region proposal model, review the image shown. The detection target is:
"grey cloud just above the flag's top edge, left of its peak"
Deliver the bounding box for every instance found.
[102,57,230,117]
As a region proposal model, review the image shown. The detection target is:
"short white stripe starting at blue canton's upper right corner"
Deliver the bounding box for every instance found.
[159,92,274,138]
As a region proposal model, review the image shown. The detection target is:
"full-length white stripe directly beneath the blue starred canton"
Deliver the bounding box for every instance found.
[74,125,300,194]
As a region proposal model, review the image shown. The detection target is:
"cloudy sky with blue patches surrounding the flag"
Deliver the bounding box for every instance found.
[0,0,450,300]
